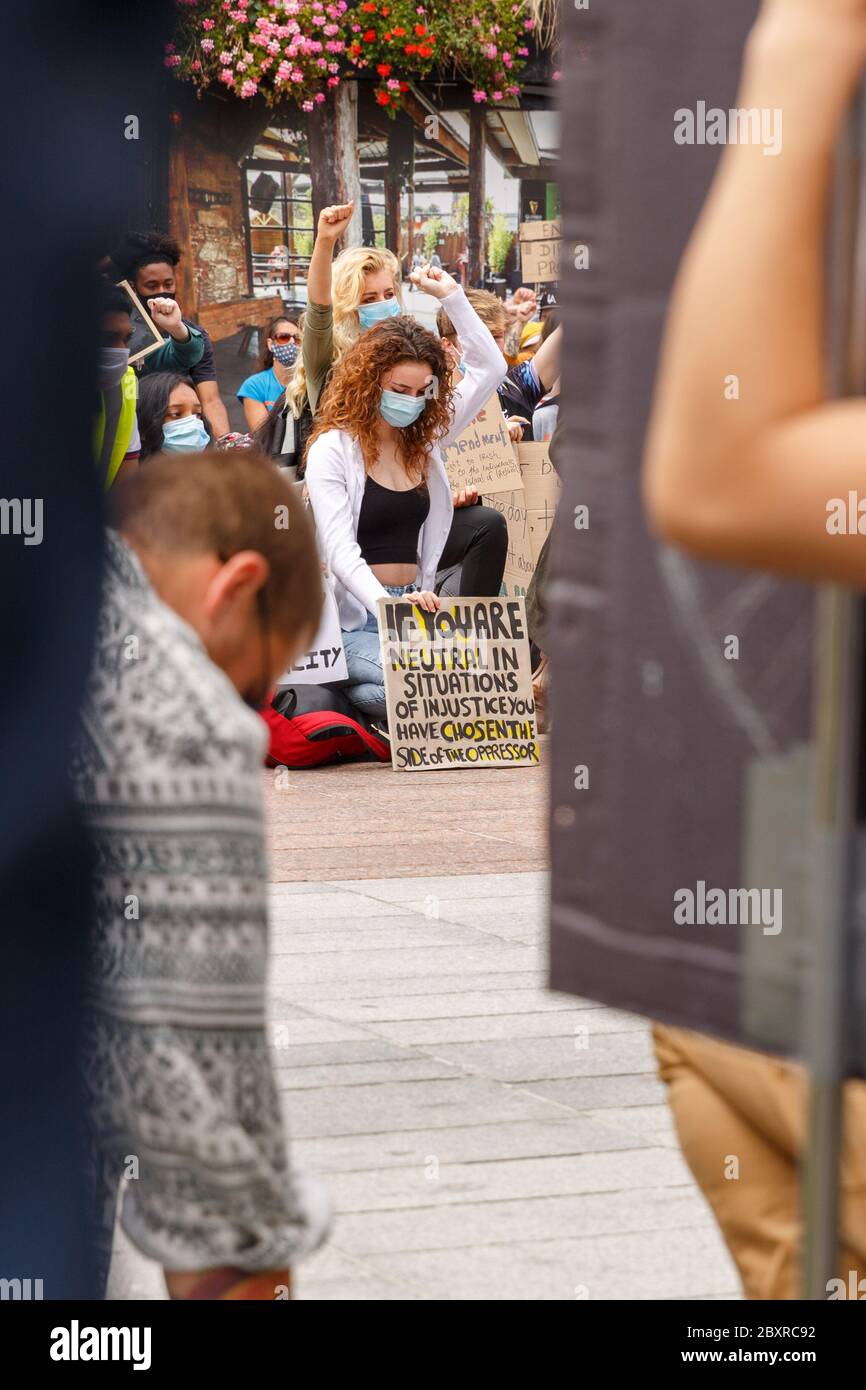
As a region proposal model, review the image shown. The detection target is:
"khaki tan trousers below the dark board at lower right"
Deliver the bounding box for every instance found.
[653,1024,866,1298]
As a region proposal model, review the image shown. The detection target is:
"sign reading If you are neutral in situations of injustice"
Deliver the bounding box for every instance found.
[378,598,539,771]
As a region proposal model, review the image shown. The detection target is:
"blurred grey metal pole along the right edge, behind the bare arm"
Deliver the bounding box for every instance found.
[802,90,866,1301]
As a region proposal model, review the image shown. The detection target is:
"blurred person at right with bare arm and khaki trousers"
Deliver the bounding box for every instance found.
[645,0,866,1298]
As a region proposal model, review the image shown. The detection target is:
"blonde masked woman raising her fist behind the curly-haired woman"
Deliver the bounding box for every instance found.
[300,203,509,598]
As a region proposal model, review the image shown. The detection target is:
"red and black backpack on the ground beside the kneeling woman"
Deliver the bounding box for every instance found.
[260,685,391,769]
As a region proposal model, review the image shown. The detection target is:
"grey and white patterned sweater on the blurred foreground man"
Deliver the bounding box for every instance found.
[74,532,329,1270]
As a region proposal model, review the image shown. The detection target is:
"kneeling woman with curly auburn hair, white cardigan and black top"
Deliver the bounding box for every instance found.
[306,268,506,720]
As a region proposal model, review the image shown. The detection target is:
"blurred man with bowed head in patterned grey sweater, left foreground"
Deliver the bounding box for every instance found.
[74,450,329,1300]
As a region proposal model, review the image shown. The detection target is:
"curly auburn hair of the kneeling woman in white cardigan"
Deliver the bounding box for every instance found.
[307,314,453,478]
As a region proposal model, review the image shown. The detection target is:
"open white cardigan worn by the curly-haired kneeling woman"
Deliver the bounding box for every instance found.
[306,289,507,632]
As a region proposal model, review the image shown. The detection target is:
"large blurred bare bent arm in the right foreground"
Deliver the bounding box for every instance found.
[644,0,866,587]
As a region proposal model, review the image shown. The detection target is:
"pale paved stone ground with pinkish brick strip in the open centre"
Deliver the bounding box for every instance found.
[113,765,738,1300]
